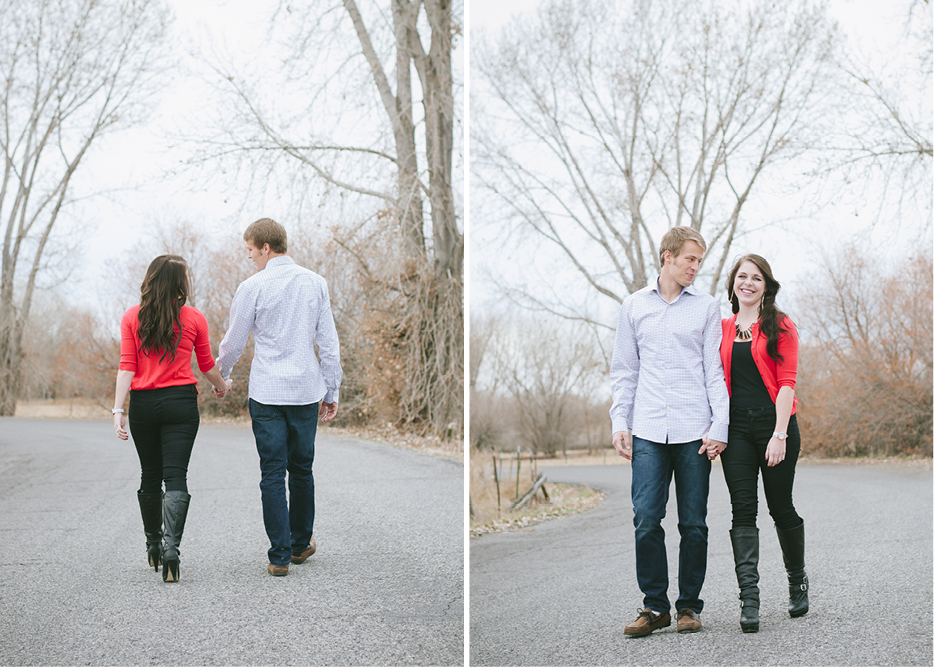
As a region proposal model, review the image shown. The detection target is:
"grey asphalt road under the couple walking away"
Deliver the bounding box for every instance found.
[0,418,464,665]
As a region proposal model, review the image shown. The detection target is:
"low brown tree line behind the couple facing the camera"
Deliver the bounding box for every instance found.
[470,245,934,457]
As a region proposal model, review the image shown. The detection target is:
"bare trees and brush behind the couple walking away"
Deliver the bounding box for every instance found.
[0,0,464,437]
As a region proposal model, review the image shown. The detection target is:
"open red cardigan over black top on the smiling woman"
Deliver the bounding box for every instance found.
[720,315,798,414]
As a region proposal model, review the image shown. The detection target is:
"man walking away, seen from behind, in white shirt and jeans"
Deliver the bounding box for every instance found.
[217,218,343,576]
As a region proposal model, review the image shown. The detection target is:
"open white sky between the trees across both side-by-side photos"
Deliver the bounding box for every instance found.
[47,0,932,324]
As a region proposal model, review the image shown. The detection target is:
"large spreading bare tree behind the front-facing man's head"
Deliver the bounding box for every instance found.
[471,0,836,326]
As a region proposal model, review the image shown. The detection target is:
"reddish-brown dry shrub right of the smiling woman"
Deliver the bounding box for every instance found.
[797,247,934,457]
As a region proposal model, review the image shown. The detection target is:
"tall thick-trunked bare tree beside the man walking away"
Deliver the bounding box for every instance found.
[188,0,464,433]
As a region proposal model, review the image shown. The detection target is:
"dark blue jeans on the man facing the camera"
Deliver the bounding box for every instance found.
[632,437,710,614]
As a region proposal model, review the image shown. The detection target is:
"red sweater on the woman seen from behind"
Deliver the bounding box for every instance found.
[120,305,214,389]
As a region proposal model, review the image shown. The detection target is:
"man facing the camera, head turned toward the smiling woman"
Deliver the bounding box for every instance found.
[610,227,730,636]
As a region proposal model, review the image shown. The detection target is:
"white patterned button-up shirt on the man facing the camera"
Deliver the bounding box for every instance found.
[610,280,730,444]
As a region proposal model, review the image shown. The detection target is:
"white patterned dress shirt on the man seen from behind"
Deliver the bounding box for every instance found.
[217,256,343,405]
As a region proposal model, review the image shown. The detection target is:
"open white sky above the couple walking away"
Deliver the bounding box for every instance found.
[61,0,464,314]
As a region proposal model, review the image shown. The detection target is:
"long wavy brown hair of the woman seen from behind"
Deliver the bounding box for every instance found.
[139,255,190,361]
